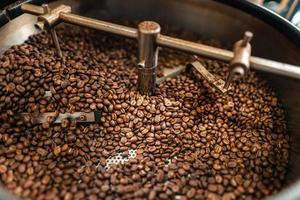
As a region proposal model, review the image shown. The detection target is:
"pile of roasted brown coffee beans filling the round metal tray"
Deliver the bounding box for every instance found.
[0,23,289,200]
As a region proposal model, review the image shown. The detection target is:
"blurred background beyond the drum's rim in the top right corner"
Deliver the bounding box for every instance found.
[250,0,300,28]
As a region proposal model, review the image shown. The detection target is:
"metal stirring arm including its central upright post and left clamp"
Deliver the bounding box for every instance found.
[21,4,300,95]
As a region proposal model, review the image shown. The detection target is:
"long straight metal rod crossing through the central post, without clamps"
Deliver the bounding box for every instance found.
[22,4,300,79]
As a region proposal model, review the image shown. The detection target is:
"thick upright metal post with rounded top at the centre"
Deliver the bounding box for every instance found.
[138,21,160,95]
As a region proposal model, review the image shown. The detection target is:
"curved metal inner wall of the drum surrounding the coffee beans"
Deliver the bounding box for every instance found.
[0,0,300,200]
